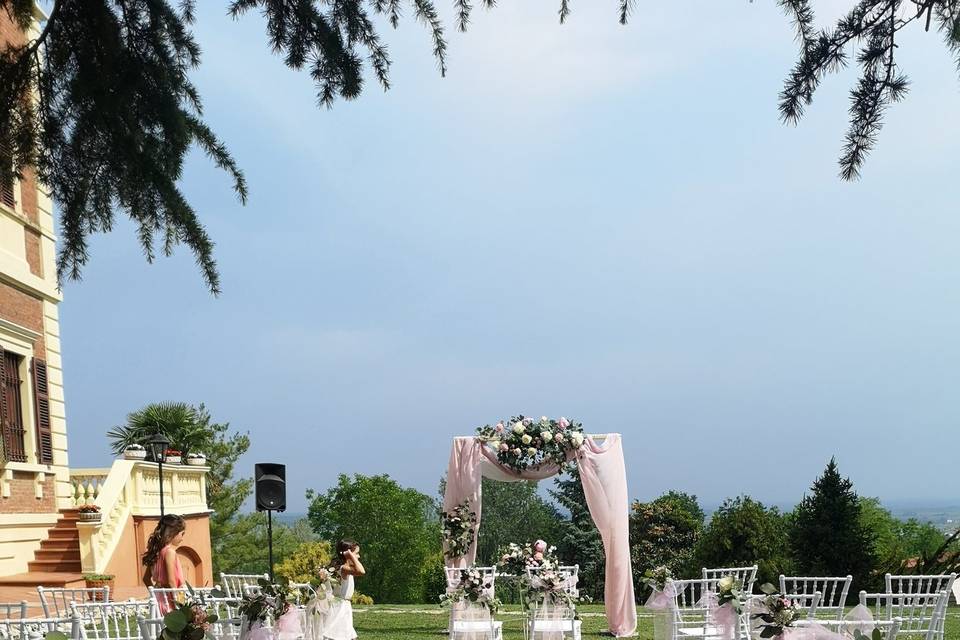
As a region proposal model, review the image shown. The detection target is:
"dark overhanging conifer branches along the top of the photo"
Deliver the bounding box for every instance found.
[0,0,960,293]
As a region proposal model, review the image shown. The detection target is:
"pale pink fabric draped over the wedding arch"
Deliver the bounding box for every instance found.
[443,433,637,637]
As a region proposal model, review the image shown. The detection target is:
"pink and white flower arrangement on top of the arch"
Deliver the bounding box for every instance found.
[477,415,586,471]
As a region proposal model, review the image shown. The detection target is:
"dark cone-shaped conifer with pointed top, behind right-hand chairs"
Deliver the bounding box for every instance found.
[790,458,877,594]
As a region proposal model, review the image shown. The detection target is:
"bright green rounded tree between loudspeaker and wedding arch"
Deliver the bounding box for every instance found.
[307,474,440,602]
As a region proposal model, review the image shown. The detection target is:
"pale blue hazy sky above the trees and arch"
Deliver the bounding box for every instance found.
[61,0,960,511]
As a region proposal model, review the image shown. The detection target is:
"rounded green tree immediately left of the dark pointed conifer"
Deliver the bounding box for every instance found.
[694,496,792,583]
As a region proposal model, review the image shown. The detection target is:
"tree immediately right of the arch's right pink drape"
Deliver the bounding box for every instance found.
[630,491,704,594]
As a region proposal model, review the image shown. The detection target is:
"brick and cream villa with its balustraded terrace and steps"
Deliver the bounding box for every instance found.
[0,9,212,586]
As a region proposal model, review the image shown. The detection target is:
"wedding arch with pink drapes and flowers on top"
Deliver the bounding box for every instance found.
[443,416,637,637]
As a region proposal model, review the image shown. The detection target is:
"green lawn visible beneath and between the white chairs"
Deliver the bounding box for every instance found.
[354,605,960,640]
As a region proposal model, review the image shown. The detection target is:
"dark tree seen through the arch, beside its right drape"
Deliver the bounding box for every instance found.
[550,467,606,600]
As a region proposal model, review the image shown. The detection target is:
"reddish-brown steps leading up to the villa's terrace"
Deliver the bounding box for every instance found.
[0,509,83,587]
